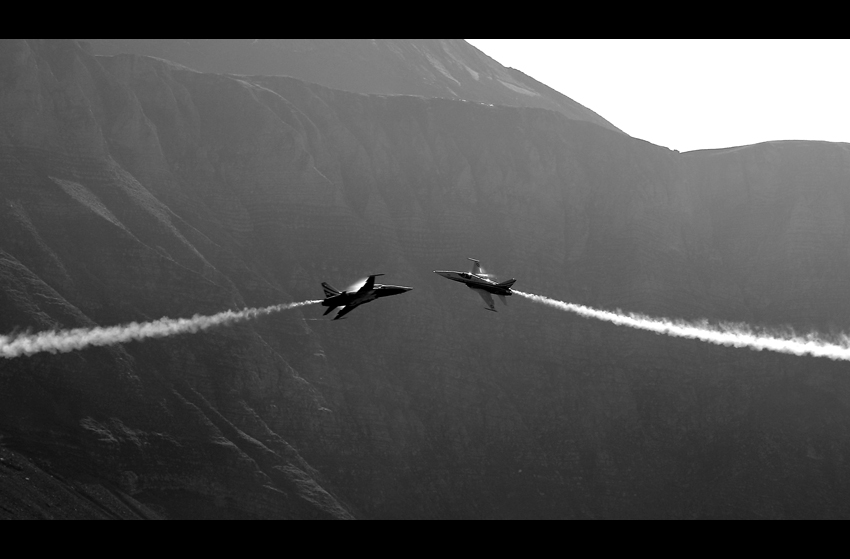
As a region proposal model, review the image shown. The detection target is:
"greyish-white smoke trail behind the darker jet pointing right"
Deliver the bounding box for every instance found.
[0,300,321,359]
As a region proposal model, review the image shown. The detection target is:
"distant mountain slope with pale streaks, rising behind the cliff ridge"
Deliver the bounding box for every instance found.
[82,39,620,135]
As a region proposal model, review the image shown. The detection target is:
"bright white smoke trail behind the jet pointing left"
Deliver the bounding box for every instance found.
[513,289,850,361]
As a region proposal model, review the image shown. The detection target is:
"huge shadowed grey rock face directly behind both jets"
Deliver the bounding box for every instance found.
[0,41,850,518]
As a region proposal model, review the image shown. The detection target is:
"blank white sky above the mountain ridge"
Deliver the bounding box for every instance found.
[467,39,850,151]
